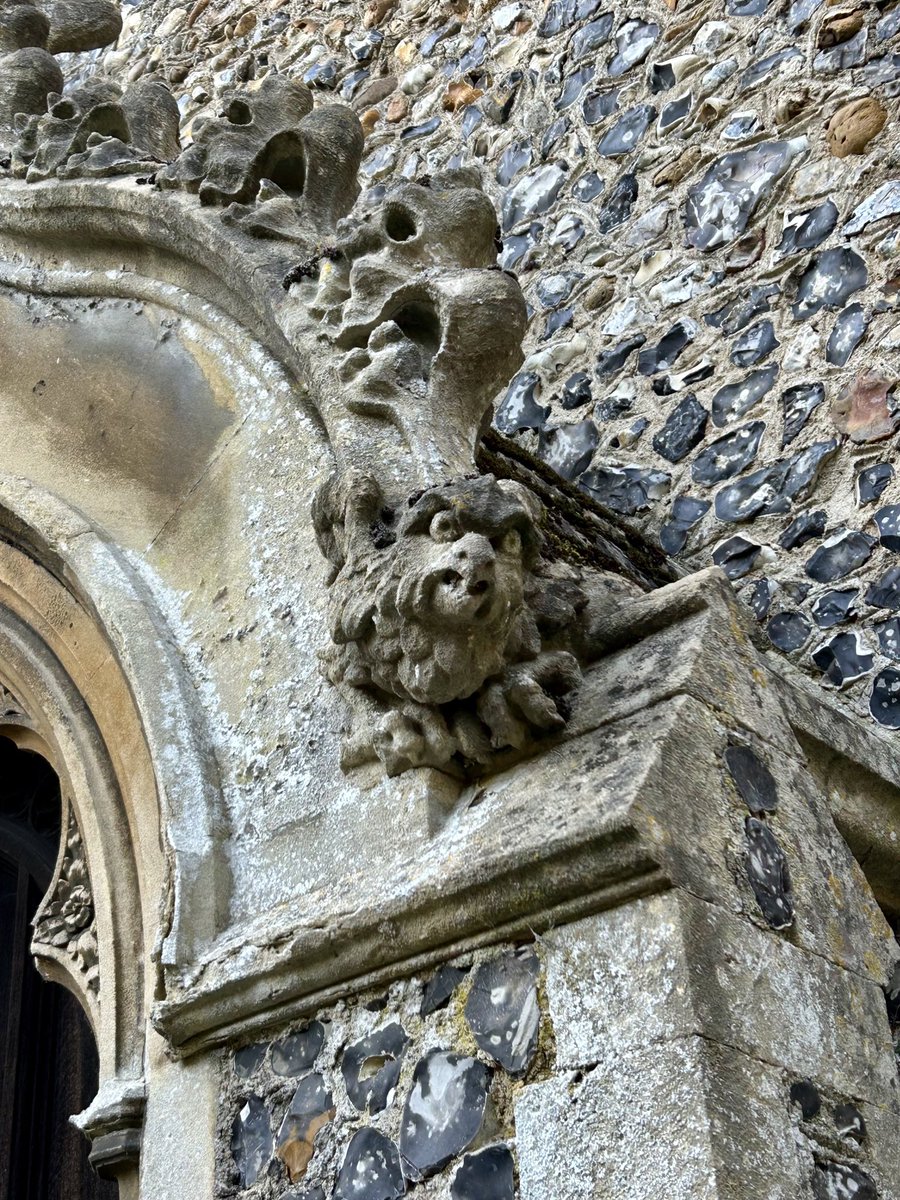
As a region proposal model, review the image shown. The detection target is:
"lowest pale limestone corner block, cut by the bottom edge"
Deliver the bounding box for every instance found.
[516,1037,804,1200]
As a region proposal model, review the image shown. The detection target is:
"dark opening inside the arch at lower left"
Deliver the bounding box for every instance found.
[0,738,119,1200]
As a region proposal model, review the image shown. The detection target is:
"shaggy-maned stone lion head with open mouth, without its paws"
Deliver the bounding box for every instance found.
[316,475,541,704]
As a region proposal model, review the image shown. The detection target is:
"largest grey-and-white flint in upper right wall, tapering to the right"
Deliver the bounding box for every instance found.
[684,142,799,250]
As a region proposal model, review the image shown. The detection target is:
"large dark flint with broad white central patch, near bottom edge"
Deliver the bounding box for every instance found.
[400,1050,491,1180]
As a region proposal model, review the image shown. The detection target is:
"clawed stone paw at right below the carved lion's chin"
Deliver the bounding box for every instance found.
[478,650,581,750]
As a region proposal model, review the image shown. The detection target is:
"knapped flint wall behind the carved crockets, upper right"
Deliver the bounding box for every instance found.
[60,0,900,728]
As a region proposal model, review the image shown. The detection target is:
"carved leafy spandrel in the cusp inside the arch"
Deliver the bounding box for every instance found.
[31,810,100,996]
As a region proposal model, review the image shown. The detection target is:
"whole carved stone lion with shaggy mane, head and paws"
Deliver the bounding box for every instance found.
[314,475,587,775]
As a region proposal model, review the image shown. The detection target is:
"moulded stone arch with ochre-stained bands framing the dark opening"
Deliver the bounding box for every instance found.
[0,478,229,1174]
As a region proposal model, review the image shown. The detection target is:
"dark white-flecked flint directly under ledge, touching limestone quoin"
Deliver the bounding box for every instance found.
[466,949,541,1075]
